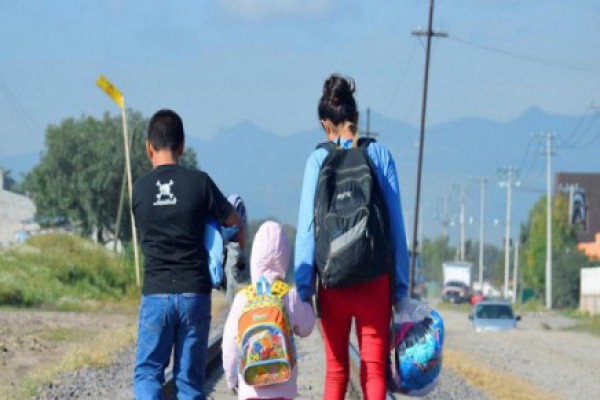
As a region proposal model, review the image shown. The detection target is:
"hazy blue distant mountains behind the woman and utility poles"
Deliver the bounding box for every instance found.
[5,107,600,244]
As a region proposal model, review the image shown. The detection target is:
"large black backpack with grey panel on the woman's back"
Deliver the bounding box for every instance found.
[314,138,393,288]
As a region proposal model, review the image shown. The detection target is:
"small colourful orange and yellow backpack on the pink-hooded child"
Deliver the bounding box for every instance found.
[238,276,296,386]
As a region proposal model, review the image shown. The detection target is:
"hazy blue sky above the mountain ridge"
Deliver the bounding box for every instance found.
[0,0,600,158]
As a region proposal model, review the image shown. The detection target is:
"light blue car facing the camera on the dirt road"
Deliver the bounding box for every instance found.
[469,300,521,332]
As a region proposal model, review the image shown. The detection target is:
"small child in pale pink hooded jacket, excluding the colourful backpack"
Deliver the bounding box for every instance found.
[223,221,315,400]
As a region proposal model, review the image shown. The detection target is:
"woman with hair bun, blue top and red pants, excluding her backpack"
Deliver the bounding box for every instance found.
[294,74,408,400]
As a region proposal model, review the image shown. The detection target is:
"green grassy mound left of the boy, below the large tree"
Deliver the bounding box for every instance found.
[0,234,135,310]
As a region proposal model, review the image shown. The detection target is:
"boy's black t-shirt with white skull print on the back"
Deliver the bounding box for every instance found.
[133,165,233,294]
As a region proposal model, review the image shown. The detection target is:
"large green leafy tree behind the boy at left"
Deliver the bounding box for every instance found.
[24,111,195,242]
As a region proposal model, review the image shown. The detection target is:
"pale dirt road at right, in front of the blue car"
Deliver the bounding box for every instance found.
[441,310,600,399]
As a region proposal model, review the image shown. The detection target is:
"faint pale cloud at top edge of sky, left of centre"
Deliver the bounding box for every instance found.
[219,0,333,21]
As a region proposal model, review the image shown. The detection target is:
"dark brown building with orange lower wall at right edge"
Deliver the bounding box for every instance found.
[555,172,600,259]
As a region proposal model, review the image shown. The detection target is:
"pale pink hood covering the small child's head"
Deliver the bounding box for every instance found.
[250,221,292,283]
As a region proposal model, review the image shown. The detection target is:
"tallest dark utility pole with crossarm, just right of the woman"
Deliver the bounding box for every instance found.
[408,0,448,297]
